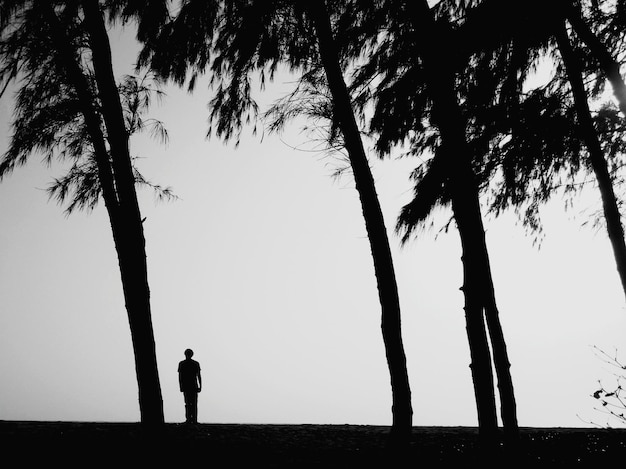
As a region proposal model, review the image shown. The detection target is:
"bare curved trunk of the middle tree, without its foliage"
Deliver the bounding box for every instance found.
[307,0,413,443]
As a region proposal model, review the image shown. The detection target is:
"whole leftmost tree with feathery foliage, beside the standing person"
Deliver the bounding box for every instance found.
[0,0,164,424]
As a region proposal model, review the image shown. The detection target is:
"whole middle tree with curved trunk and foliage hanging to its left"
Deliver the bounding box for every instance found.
[143,0,412,442]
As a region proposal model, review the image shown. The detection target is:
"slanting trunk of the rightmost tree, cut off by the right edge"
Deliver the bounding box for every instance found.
[556,23,626,304]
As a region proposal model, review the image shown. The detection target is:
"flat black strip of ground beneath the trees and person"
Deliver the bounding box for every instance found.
[0,421,626,468]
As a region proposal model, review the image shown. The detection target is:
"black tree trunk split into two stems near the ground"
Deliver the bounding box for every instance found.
[405,1,519,444]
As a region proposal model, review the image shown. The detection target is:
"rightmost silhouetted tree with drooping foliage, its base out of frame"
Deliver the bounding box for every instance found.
[442,0,626,304]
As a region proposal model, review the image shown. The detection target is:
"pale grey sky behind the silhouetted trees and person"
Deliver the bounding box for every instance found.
[0,24,626,427]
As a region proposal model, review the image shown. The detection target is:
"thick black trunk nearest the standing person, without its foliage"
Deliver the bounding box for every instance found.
[82,0,164,424]
